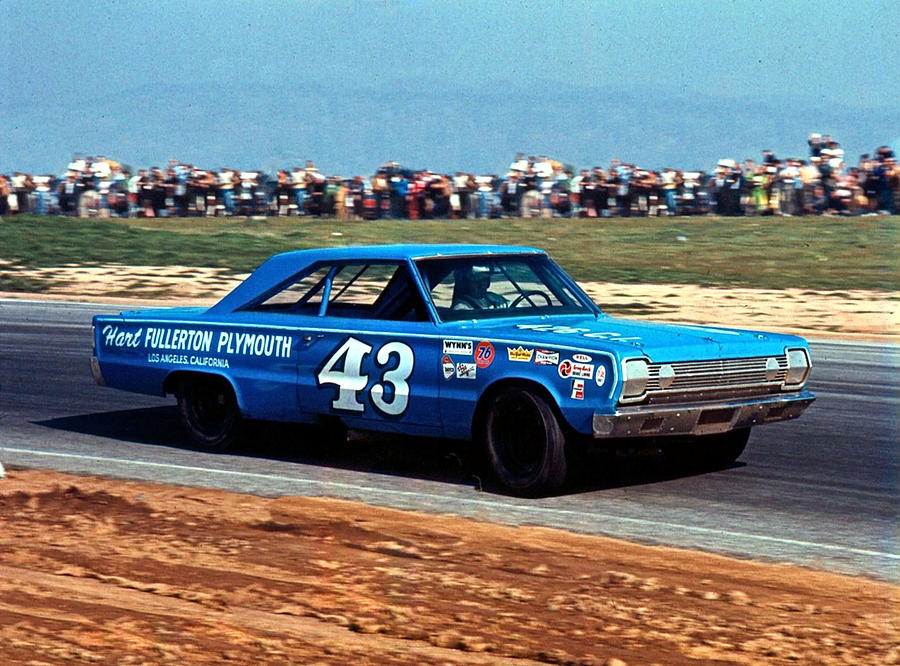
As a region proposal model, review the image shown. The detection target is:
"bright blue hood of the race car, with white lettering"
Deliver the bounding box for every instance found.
[446,315,806,363]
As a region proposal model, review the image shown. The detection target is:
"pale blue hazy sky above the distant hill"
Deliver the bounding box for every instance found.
[0,0,900,172]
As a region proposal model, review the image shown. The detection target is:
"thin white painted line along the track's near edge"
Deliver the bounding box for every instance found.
[0,447,900,561]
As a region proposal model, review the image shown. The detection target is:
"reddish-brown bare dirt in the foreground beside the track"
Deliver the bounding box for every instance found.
[0,470,900,666]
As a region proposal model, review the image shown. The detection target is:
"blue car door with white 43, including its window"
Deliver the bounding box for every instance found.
[297,262,440,434]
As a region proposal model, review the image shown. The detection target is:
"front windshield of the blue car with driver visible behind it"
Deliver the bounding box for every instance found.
[416,255,596,321]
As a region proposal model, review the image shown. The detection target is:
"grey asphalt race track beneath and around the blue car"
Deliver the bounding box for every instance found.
[0,300,900,582]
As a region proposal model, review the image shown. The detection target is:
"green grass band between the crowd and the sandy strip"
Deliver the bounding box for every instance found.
[0,215,900,291]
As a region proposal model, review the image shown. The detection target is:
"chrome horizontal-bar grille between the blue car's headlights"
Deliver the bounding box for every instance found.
[647,356,788,393]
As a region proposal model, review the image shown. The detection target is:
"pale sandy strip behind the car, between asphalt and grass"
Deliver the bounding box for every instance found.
[0,265,900,342]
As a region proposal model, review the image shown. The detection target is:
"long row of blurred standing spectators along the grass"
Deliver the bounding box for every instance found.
[0,134,900,219]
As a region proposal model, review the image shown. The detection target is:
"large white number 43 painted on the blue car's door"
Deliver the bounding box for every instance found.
[316,338,415,416]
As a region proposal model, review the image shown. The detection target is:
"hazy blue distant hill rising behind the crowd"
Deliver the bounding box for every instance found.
[0,73,900,176]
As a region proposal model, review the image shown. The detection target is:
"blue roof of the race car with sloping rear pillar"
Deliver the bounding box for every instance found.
[210,243,546,312]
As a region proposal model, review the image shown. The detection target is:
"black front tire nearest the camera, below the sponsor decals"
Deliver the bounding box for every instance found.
[483,387,566,496]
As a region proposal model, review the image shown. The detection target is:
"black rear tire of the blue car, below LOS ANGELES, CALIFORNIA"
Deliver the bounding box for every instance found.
[176,376,242,452]
